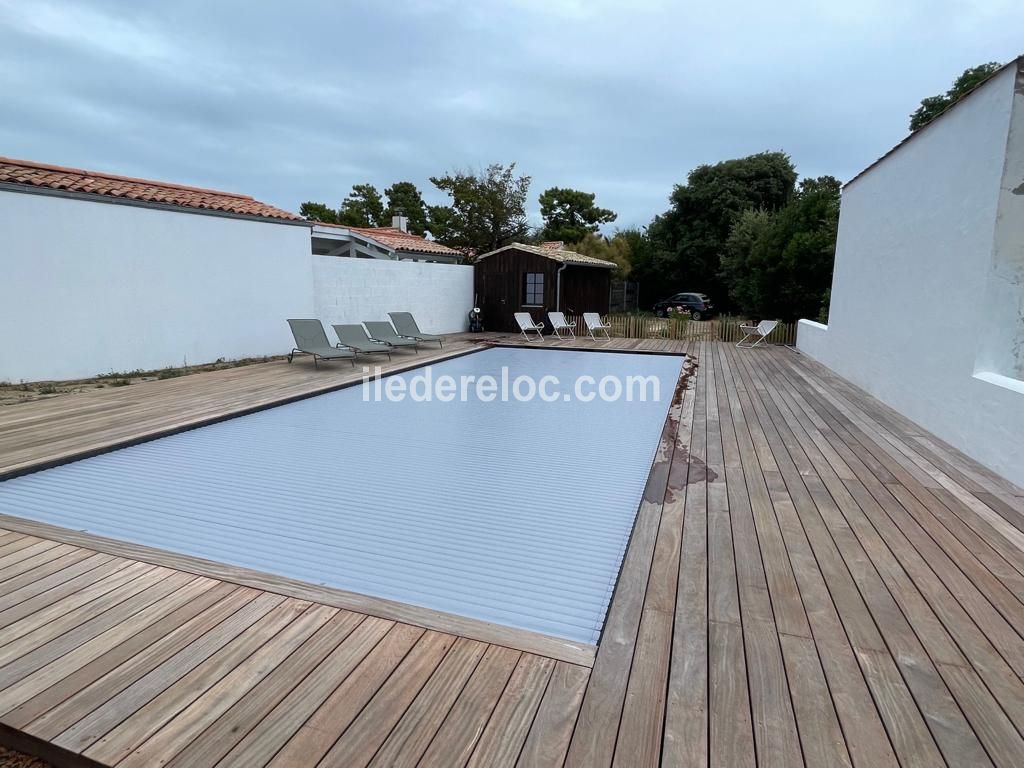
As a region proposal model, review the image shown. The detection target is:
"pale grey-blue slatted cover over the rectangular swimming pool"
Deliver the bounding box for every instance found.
[0,348,683,642]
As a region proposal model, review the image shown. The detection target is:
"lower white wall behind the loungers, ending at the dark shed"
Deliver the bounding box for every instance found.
[311,256,473,338]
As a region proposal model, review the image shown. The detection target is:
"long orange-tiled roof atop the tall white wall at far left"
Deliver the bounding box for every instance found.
[0,157,302,221]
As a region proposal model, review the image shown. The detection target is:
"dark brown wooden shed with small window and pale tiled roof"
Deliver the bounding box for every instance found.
[474,243,615,332]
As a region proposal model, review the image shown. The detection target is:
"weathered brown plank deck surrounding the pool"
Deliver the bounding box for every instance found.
[0,337,1024,768]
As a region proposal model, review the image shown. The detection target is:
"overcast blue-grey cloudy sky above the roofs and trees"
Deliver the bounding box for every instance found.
[0,0,1024,226]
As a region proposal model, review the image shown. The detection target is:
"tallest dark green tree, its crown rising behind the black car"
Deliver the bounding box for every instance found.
[637,152,797,308]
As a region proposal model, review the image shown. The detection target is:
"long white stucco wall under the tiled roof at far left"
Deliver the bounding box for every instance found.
[0,190,313,381]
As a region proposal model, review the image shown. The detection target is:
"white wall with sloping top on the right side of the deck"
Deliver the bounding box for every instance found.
[797,68,1024,485]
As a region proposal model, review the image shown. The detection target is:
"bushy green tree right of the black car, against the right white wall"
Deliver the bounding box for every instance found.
[722,176,841,321]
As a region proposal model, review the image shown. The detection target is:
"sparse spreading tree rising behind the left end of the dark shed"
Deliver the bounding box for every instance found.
[427,163,530,256]
